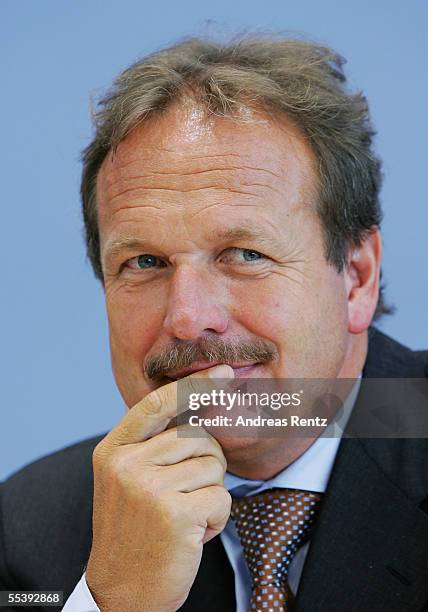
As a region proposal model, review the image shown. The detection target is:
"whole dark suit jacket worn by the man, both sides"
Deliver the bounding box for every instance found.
[0,328,428,612]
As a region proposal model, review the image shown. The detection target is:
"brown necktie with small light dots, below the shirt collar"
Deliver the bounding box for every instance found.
[231,489,321,612]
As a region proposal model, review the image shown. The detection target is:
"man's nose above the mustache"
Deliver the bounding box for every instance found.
[164,264,228,340]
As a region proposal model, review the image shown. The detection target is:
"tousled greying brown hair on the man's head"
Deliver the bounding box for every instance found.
[81,36,392,319]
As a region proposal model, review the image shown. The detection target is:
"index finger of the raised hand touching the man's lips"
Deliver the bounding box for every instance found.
[102,364,234,446]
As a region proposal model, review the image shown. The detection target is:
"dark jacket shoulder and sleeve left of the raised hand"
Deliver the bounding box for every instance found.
[0,436,103,595]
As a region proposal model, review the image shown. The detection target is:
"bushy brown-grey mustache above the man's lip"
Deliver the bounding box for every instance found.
[144,338,278,380]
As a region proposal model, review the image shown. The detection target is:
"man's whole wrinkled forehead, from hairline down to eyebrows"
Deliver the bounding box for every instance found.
[97,101,317,246]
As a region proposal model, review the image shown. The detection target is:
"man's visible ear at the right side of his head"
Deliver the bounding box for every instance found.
[345,229,382,334]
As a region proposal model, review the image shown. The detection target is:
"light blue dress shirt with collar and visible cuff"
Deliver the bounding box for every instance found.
[62,374,361,612]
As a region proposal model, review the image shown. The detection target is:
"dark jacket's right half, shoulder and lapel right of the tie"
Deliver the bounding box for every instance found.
[295,328,428,612]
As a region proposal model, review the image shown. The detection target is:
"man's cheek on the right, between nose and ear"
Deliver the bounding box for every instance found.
[233,270,347,377]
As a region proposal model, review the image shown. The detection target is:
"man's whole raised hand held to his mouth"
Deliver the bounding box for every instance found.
[86,365,233,612]
